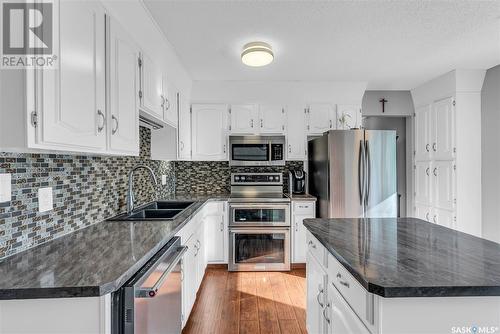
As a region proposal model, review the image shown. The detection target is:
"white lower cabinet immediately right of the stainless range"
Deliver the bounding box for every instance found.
[292,201,316,263]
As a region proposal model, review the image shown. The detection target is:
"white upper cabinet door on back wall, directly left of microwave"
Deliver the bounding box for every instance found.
[191,104,228,161]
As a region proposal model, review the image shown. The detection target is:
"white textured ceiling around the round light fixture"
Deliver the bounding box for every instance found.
[144,0,500,89]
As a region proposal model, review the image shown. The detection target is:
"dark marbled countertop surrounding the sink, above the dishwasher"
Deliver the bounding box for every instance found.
[0,194,229,300]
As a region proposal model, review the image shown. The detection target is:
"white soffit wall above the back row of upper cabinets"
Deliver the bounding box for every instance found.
[191,81,366,104]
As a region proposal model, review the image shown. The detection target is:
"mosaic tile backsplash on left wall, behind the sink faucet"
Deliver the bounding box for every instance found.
[0,127,175,259]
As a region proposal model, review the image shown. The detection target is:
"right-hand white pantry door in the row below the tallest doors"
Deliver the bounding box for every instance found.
[432,161,455,210]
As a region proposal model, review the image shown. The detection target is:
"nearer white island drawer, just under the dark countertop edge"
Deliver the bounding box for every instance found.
[328,254,375,327]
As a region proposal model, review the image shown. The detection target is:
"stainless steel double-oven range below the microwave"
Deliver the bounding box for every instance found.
[228,173,290,271]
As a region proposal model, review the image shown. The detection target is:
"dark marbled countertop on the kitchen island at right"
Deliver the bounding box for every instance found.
[304,218,500,297]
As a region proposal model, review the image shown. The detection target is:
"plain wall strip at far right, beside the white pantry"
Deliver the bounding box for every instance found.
[481,65,500,242]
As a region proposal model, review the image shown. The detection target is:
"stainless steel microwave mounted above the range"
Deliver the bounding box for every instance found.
[229,136,285,166]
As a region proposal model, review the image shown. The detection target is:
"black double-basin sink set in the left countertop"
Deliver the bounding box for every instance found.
[109,201,195,221]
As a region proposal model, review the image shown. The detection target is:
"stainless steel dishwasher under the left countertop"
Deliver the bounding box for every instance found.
[112,237,187,334]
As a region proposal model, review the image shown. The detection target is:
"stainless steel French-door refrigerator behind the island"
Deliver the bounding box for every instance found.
[308,130,398,218]
